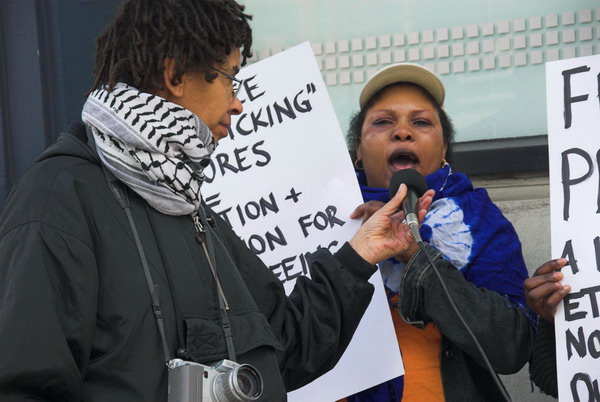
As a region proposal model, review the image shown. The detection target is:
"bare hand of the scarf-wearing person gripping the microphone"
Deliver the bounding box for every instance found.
[350,184,434,264]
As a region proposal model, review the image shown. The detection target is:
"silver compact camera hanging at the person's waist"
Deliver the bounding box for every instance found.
[167,359,263,402]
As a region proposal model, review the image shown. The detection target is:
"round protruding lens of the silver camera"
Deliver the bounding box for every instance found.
[213,364,262,401]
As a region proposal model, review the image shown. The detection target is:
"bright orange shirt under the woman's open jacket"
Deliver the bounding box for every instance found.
[392,295,444,402]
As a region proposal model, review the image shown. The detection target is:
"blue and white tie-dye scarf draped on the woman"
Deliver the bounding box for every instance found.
[348,164,535,402]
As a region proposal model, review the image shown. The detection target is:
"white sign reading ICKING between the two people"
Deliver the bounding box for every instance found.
[202,42,404,401]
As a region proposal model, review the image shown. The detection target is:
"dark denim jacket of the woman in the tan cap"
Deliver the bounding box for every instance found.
[398,246,533,401]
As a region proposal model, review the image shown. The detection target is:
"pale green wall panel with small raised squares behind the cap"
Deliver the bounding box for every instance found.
[242,0,600,142]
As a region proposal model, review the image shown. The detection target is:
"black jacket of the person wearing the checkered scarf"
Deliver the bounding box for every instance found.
[0,125,375,401]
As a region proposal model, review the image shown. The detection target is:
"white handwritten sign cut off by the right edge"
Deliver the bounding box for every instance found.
[546,56,600,401]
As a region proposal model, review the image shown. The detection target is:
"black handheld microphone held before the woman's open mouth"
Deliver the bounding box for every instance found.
[389,169,428,243]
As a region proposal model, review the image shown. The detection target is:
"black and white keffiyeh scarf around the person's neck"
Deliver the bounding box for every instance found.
[81,83,215,215]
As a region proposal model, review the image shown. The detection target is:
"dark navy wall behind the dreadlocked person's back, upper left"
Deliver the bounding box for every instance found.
[0,0,119,209]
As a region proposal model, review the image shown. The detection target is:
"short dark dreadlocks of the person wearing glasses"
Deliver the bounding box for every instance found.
[88,0,252,93]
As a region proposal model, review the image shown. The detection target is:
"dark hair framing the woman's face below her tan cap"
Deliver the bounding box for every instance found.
[346,82,455,162]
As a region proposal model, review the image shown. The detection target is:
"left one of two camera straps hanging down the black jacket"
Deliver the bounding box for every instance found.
[102,166,171,363]
